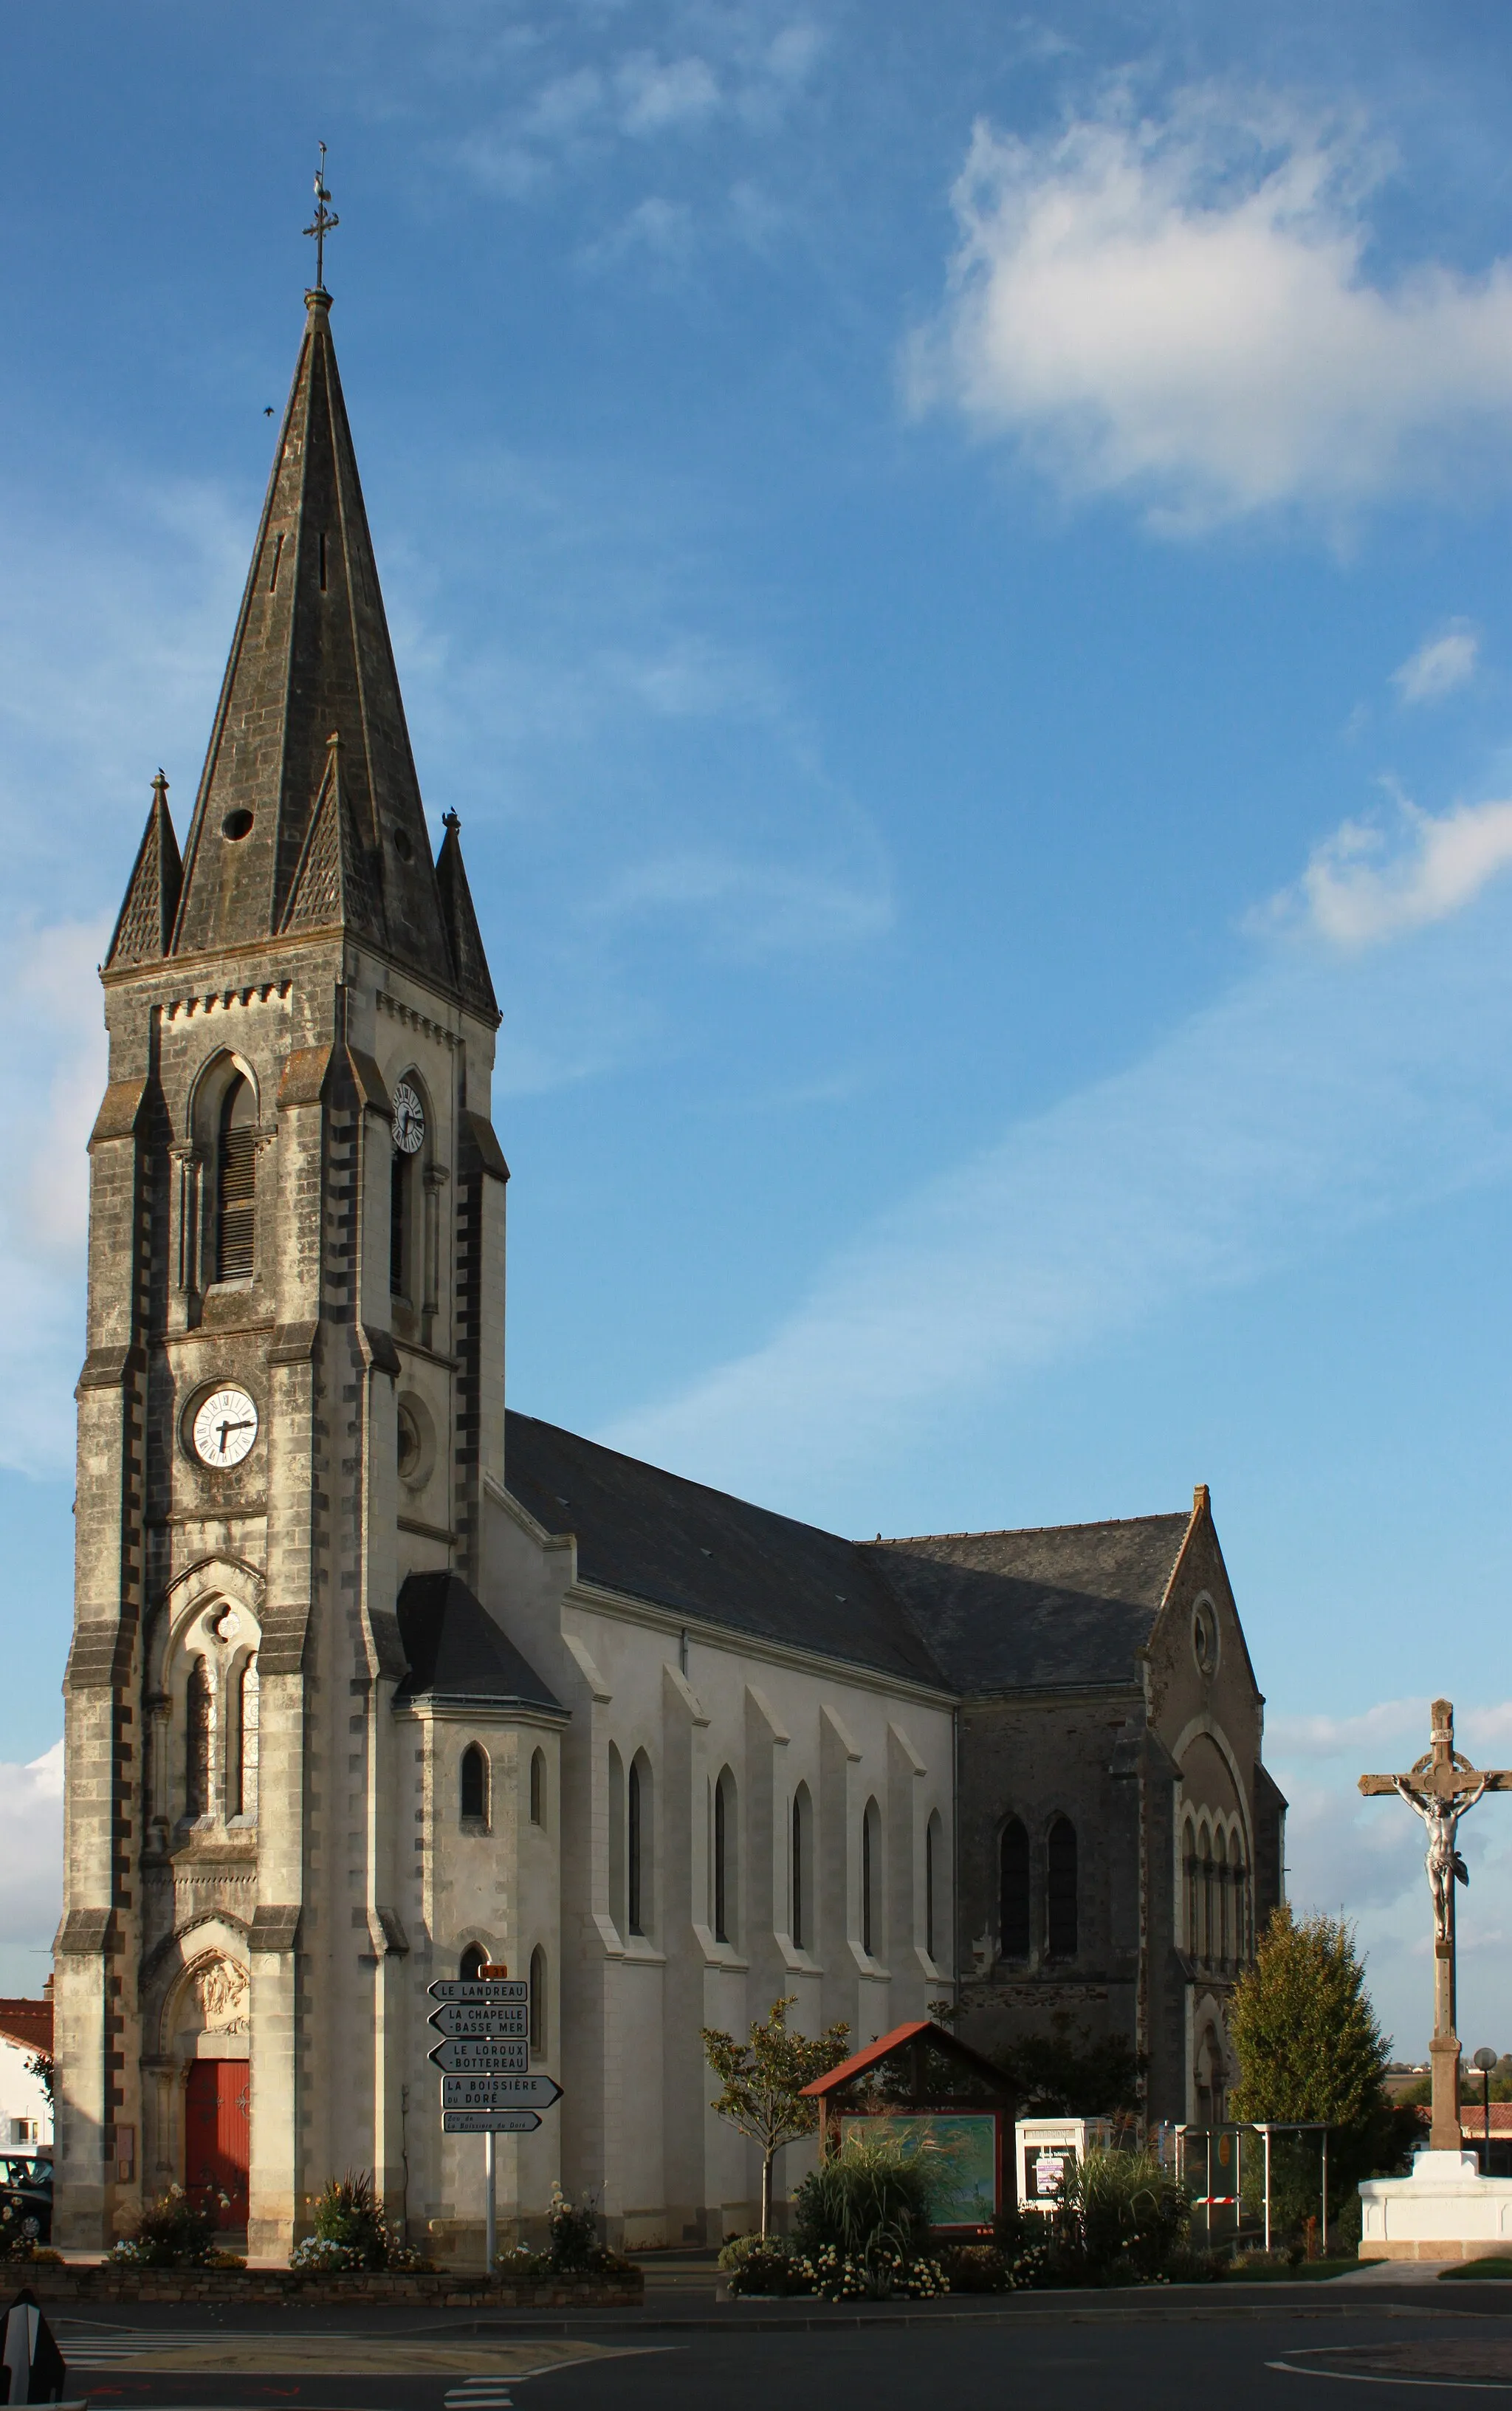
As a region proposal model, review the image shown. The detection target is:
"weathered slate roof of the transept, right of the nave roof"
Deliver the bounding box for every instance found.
[866,1514,1192,1692]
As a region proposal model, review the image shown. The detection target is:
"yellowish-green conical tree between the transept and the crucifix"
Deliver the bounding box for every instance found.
[1228,1904,1403,2184]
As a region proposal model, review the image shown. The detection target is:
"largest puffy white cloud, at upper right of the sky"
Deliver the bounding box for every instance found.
[909,92,1512,528]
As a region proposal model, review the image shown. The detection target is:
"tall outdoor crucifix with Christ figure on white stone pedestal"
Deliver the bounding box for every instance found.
[1360,1700,1512,2262]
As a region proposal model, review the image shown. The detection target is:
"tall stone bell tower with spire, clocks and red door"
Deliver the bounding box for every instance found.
[55,269,509,2252]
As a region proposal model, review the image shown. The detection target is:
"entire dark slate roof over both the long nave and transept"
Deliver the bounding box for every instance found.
[504,1410,1192,1692]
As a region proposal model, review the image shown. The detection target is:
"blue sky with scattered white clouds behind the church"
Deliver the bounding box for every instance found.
[0,0,1512,2052]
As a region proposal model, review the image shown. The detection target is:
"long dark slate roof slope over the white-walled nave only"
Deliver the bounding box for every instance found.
[504,1413,945,1690]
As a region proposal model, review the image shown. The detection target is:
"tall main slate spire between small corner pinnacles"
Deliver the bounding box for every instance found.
[173,292,456,989]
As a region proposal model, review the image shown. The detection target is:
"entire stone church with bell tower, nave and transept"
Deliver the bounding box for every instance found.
[55,280,1285,2264]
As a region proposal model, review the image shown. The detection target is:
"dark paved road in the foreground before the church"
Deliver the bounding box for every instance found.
[53,2298,1512,2411]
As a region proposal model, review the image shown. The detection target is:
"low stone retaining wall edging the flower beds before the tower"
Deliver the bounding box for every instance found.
[0,2262,644,2310]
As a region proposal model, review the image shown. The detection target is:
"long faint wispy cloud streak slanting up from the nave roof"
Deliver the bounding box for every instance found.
[603,820,1512,1517]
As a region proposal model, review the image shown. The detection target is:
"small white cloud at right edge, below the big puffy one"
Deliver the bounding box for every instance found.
[1268,803,1512,947]
